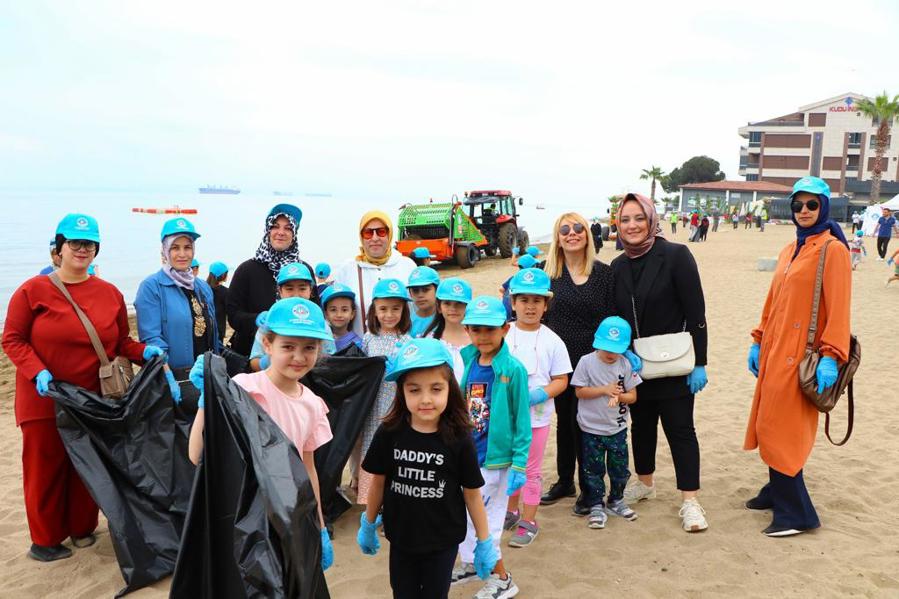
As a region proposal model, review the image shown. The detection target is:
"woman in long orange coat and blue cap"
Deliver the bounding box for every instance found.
[743,177,852,537]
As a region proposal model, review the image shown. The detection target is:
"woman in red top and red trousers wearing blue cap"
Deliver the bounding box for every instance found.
[3,214,162,561]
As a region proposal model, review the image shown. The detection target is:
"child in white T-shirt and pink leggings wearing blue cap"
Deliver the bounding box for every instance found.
[503,268,571,547]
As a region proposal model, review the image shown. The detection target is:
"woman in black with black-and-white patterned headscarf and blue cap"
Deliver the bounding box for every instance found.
[228,204,318,356]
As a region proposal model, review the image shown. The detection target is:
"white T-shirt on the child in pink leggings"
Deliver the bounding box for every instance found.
[506,322,572,428]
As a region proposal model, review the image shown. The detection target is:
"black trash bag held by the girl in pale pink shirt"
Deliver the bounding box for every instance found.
[170,353,329,599]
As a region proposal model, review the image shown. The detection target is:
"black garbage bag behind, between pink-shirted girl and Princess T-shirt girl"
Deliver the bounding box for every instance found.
[303,354,385,522]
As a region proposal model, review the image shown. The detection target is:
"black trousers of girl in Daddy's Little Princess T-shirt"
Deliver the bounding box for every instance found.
[390,543,459,599]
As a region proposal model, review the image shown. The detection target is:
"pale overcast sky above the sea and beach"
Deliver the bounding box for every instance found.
[0,0,899,204]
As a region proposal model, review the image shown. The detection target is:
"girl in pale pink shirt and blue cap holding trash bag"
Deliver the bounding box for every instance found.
[188,298,334,570]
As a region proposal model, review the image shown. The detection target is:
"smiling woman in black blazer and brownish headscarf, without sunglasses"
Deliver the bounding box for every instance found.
[612,193,708,532]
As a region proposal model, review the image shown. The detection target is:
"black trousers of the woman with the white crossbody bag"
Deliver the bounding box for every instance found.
[624,394,699,491]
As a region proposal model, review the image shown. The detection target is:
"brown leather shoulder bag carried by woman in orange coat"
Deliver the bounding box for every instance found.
[799,239,862,445]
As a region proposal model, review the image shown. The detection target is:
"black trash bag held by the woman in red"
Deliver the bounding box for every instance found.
[50,358,195,596]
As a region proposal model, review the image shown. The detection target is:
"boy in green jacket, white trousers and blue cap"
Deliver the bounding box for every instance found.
[452,295,531,597]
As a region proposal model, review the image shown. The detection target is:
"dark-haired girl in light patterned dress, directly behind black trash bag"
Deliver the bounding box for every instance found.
[358,279,412,505]
